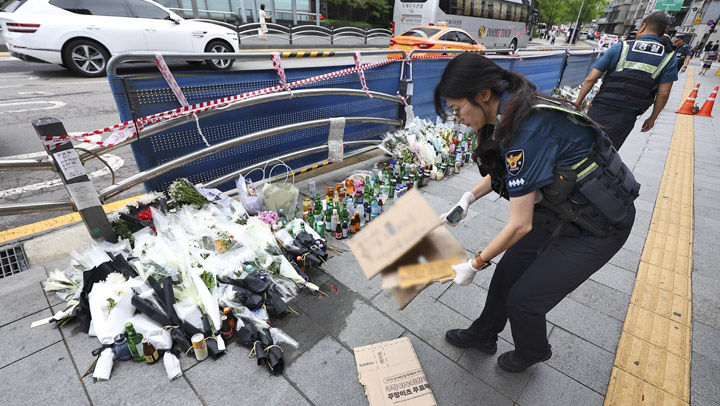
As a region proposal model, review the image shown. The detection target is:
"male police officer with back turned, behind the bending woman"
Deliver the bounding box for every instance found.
[575,11,677,149]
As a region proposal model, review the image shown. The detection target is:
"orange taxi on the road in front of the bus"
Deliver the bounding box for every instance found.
[390,21,485,57]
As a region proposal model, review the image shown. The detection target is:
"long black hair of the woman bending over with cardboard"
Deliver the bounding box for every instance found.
[435,53,539,148]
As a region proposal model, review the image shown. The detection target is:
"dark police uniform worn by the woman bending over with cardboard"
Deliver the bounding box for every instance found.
[467,95,640,361]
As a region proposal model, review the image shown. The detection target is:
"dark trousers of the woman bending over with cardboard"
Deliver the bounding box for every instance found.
[468,208,635,361]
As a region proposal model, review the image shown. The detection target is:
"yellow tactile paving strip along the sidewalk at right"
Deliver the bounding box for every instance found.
[605,68,695,405]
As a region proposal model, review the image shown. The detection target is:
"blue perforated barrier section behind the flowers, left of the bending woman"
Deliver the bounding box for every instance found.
[109,63,400,190]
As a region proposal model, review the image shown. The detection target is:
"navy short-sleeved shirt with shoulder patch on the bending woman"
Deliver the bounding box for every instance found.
[500,109,597,197]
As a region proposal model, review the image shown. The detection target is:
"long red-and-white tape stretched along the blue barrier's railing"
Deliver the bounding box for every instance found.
[41,54,402,148]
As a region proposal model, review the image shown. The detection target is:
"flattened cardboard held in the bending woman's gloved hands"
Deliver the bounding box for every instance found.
[348,189,467,309]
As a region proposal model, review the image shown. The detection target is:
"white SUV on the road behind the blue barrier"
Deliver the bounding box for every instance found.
[0,0,238,77]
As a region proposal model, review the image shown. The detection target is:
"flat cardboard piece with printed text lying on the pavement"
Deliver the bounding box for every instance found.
[353,337,437,406]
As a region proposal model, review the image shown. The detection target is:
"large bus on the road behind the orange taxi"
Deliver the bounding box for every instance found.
[393,0,537,50]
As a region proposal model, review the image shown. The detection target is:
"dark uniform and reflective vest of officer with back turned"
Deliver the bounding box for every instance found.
[588,34,677,149]
